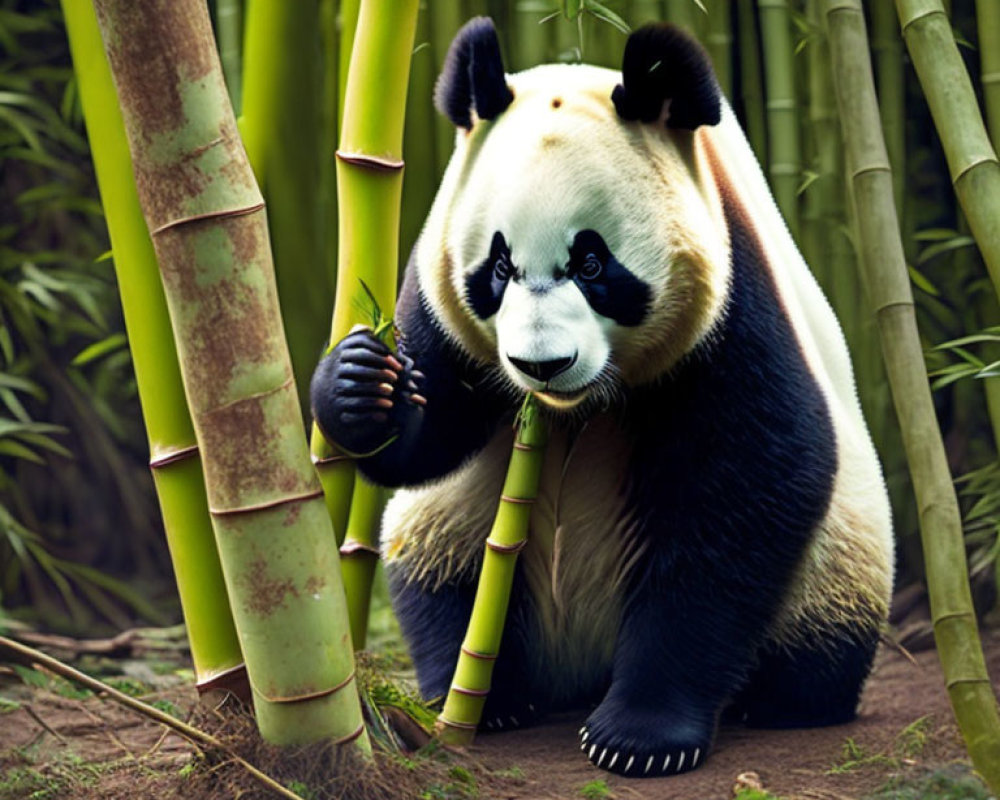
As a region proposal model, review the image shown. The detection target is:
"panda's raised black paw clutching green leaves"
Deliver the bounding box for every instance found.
[310,330,427,456]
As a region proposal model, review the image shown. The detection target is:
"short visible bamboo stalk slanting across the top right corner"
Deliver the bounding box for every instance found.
[896,0,1000,295]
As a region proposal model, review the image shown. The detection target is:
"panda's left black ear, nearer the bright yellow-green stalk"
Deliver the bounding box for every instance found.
[434,17,514,130]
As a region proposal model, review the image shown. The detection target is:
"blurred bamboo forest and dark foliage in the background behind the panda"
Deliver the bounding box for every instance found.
[0,0,1000,634]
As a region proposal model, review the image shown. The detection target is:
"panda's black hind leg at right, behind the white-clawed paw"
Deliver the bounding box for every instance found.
[725,628,879,728]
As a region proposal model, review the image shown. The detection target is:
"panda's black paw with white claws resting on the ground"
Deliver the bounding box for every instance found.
[580,698,715,778]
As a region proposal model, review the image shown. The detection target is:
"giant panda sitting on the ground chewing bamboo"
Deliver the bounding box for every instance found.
[311,18,893,776]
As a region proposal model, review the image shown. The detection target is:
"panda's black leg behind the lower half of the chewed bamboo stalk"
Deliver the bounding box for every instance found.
[387,565,548,731]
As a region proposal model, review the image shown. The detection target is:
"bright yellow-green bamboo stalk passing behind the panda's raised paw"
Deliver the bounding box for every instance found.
[312,0,419,640]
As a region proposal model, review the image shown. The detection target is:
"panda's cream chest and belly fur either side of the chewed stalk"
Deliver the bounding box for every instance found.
[383,416,642,702]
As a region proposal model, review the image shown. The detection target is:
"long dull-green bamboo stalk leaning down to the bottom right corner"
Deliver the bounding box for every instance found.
[824,0,1000,791]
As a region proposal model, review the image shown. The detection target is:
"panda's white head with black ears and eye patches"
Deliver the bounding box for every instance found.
[417,19,729,408]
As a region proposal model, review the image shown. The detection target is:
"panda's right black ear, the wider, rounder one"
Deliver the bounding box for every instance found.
[611,23,722,130]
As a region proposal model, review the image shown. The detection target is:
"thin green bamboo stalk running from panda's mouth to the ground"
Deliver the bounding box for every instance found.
[436,404,548,745]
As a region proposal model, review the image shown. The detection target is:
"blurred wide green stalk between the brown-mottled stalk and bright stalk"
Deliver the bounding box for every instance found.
[239,0,334,409]
